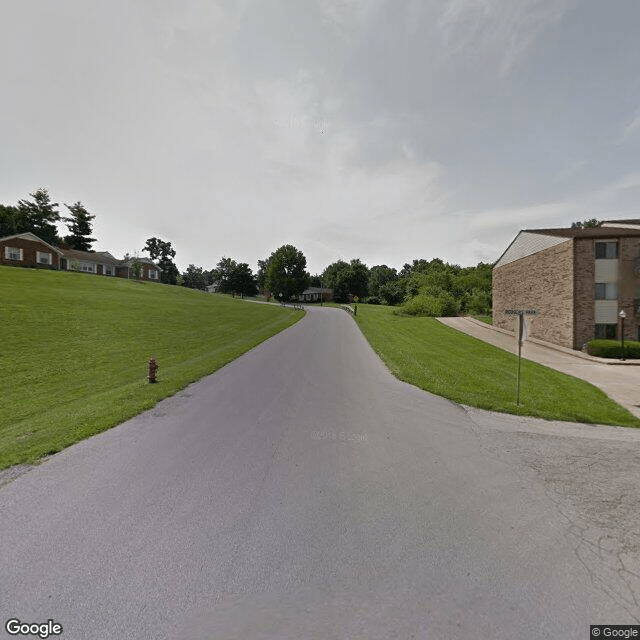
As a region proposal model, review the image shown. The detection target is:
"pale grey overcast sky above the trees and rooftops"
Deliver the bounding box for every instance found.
[0,0,640,273]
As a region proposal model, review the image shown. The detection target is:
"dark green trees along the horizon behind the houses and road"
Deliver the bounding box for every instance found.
[0,188,496,316]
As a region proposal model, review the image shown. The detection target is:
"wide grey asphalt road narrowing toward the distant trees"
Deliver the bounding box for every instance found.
[0,308,640,640]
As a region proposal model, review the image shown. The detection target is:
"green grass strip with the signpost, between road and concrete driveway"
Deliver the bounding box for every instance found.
[356,304,640,427]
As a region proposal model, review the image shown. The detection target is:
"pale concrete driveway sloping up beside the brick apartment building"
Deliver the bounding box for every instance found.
[438,318,640,418]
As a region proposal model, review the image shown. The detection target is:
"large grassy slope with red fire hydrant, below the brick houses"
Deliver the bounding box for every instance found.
[0,267,303,469]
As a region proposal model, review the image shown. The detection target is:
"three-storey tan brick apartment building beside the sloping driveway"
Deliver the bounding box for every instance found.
[493,220,640,349]
